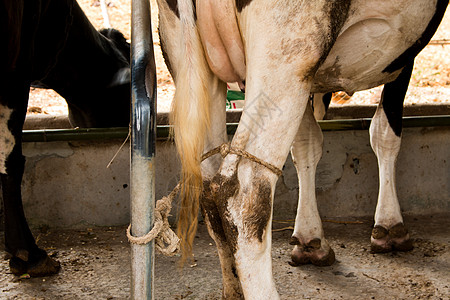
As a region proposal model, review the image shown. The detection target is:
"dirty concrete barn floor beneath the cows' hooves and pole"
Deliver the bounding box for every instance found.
[0,214,450,300]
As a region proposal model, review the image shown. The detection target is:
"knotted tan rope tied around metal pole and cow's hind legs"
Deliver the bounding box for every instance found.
[127,143,283,256]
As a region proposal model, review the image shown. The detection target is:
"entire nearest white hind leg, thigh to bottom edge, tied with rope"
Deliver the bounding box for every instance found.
[215,1,349,299]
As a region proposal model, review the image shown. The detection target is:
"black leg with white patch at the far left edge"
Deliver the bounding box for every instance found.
[0,75,60,277]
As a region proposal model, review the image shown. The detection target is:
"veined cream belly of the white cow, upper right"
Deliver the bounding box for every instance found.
[312,0,437,93]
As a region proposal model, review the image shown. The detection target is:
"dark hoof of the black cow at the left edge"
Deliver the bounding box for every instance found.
[9,250,61,277]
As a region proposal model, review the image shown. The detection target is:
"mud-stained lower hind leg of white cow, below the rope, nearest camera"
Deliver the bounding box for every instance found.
[216,159,278,299]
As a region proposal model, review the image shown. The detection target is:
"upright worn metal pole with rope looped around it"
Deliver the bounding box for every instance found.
[130,0,156,300]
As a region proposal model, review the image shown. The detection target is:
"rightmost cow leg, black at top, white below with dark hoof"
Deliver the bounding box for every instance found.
[370,63,413,252]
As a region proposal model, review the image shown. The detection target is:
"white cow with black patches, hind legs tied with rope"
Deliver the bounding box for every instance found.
[158,0,448,299]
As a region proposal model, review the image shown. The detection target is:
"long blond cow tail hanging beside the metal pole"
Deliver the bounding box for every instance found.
[171,0,210,263]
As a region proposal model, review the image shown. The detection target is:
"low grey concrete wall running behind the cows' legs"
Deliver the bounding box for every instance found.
[1,127,450,227]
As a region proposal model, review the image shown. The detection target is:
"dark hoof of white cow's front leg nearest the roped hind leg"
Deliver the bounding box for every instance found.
[289,236,336,267]
